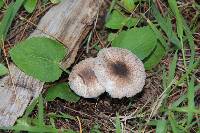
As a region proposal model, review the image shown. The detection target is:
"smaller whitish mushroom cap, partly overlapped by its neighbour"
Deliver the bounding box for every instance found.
[69,58,105,98]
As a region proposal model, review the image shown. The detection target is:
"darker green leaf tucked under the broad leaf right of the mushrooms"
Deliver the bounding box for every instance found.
[144,43,165,70]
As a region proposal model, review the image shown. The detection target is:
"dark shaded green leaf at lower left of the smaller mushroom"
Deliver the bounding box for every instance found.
[46,83,80,102]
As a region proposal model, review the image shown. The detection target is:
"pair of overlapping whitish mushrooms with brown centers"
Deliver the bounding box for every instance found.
[69,47,146,98]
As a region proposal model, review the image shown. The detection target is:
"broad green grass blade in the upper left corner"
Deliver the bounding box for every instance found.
[0,0,24,46]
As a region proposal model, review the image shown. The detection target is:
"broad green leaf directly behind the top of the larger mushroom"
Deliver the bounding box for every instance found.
[112,26,157,60]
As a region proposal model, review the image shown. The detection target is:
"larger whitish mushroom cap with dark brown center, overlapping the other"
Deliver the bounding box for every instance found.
[94,47,146,98]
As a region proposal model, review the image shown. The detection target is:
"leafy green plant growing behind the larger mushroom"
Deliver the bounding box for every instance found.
[105,1,167,70]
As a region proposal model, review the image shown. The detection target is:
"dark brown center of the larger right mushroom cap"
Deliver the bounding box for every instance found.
[111,61,129,78]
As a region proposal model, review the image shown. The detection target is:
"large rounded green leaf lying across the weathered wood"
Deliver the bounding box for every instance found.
[10,37,66,82]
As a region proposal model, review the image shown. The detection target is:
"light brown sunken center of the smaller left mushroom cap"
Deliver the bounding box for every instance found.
[78,68,96,86]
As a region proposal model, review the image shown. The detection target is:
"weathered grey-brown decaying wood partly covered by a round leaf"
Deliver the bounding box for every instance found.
[0,0,101,126]
